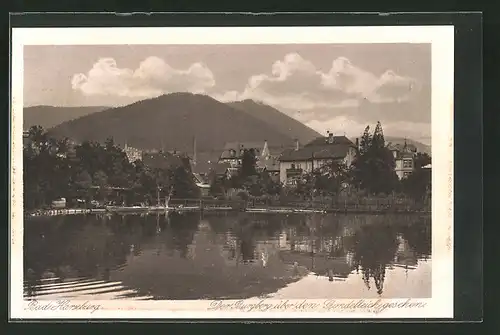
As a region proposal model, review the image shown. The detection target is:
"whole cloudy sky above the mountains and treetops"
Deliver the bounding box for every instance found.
[24,43,431,144]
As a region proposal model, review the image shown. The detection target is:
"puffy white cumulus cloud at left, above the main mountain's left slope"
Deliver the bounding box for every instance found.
[71,57,215,98]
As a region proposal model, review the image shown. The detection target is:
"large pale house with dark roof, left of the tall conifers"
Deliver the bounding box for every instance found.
[279,132,358,185]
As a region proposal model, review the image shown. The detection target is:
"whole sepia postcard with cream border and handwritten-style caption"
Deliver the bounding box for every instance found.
[10,26,454,319]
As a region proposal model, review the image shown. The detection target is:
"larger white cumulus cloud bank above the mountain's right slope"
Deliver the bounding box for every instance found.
[215,53,420,109]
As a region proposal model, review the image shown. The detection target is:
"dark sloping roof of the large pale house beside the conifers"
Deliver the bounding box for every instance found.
[279,136,356,162]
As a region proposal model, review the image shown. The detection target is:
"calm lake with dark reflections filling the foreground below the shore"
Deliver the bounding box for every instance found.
[24,213,432,300]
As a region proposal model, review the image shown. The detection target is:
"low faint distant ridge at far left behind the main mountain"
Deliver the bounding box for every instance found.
[23,106,108,130]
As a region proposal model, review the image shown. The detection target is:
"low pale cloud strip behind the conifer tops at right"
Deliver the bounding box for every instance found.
[306,116,431,140]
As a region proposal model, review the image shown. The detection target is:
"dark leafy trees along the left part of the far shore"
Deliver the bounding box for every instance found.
[23,126,199,209]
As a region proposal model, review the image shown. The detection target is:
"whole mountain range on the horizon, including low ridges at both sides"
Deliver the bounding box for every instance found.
[24,92,431,154]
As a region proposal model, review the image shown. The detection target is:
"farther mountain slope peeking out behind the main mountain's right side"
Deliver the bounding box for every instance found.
[227,99,321,144]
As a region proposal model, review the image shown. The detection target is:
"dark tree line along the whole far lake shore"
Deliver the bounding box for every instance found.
[23,122,431,209]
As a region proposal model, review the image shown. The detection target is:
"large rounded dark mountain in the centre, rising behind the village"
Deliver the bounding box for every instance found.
[50,93,301,152]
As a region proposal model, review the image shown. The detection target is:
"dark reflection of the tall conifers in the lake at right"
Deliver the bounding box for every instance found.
[352,224,398,294]
